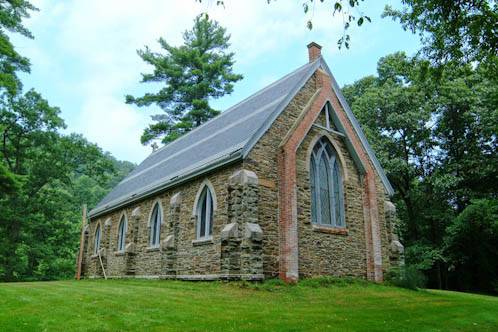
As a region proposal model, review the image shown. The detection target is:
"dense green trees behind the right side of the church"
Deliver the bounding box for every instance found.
[344,53,498,291]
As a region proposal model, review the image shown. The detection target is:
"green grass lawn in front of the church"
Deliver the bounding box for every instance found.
[0,280,498,331]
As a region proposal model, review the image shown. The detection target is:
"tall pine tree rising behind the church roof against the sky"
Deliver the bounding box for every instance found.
[126,15,242,144]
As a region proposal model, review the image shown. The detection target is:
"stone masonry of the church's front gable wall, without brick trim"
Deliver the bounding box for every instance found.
[244,70,398,279]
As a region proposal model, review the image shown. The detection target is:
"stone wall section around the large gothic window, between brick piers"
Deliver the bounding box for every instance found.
[297,128,366,278]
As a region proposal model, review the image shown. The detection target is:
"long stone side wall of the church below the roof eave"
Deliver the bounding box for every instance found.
[83,164,263,279]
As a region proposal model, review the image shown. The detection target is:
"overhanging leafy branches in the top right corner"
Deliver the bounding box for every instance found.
[383,0,498,66]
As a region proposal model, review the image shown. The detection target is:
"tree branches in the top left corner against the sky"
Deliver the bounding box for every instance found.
[0,0,37,95]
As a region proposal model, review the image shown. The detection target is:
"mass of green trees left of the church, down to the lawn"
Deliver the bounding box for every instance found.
[0,90,133,280]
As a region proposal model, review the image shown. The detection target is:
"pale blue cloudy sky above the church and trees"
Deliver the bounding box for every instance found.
[13,0,420,163]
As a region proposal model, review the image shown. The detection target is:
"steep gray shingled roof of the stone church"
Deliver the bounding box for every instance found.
[89,58,392,217]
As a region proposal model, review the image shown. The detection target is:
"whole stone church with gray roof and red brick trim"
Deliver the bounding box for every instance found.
[78,43,403,282]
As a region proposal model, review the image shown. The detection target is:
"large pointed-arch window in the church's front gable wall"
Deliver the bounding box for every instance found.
[310,137,345,227]
